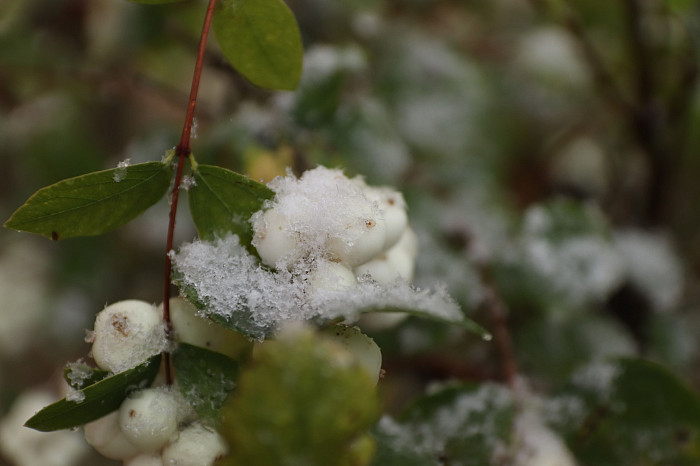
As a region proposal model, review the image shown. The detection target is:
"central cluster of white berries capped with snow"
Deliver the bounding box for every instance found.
[251,167,417,289]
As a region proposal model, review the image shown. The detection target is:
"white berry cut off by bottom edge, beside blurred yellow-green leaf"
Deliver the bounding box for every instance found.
[163,424,228,466]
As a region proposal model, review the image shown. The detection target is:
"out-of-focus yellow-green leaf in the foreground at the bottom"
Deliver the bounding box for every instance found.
[221,330,379,466]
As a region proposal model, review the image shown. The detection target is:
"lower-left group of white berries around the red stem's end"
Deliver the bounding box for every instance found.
[85,298,231,466]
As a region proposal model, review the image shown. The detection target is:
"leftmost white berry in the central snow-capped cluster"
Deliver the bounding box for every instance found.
[252,209,301,267]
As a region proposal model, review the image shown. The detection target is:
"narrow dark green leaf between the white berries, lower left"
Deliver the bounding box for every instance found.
[24,355,161,432]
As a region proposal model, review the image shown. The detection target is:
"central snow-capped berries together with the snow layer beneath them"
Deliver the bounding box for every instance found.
[173,167,462,338]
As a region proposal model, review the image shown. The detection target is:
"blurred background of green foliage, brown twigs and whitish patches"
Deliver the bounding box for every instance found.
[0,0,700,464]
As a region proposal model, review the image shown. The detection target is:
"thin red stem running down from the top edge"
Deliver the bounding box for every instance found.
[163,0,216,385]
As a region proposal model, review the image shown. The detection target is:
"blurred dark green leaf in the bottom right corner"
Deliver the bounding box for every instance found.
[551,359,700,466]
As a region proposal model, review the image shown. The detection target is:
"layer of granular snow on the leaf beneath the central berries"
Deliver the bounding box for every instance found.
[174,235,462,339]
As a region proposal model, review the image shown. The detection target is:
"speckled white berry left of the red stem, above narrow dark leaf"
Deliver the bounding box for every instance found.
[92,300,167,372]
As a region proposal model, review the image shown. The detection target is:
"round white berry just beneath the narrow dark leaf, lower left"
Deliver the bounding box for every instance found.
[119,388,178,452]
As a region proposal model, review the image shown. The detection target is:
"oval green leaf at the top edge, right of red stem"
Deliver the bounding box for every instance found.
[213,0,304,90]
